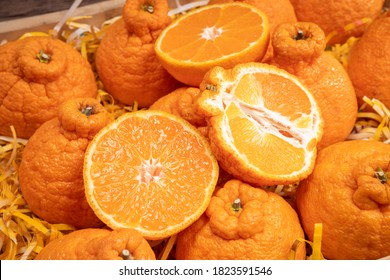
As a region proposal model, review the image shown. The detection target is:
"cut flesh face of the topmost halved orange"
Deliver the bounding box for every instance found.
[160,6,263,62]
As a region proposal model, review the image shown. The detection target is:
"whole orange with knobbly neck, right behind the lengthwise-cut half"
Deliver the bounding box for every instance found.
[271,22,358,149]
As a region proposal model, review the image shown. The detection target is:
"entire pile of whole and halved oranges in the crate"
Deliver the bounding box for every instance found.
[0,0,390,260]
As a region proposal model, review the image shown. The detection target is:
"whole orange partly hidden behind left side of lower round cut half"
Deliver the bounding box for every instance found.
[18,98,110,228]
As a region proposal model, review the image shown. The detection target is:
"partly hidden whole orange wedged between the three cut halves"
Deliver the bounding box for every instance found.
[149,87,206,127]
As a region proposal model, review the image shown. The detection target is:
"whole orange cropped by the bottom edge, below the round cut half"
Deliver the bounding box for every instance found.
[35,228,156,260]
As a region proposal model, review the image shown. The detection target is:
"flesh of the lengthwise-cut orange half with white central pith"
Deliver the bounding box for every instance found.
[221,73,311,174]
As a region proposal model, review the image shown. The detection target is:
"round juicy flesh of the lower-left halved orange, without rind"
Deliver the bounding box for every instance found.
[87,116,214,231]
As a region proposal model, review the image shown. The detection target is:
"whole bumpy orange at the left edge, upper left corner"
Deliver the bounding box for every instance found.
[0,37,97,138]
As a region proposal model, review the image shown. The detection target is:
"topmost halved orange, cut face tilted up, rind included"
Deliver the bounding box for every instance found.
[155,2,269,87]
